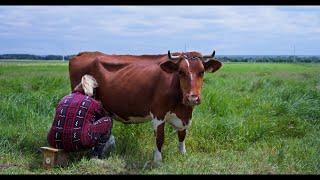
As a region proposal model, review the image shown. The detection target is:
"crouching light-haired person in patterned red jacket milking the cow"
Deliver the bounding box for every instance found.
[47,75,114,159]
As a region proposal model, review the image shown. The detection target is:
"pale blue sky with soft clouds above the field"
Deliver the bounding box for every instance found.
[0,6,320,55]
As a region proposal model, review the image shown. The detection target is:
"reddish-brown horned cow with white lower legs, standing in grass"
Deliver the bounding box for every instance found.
[69,51,222,162]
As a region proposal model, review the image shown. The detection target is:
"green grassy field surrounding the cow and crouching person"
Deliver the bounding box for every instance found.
[0,61,320,174]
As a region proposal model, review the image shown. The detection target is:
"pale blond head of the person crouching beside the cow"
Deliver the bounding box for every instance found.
[74,74,98,97]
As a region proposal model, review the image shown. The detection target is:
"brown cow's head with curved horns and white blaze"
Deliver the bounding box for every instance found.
[160,51,222,106]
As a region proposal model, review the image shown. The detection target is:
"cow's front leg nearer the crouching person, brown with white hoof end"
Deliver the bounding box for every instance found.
[153,119,165,162]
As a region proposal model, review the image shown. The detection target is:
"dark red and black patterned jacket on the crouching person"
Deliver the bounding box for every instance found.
[47,91,112,151]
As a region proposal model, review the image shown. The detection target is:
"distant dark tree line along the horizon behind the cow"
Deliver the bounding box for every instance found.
[0,54,320,63]
